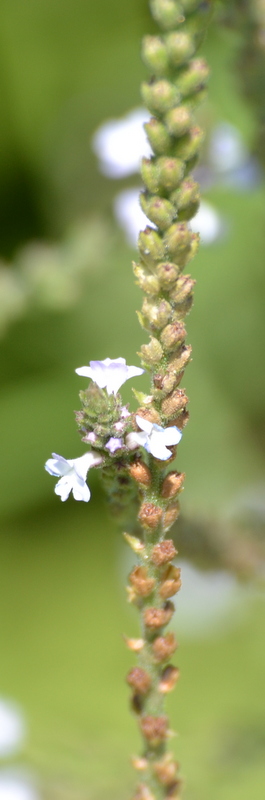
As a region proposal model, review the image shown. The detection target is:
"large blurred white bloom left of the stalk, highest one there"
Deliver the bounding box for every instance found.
[92,108,152,178]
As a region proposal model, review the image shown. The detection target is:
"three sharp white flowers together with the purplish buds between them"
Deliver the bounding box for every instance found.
[45,358,182,503]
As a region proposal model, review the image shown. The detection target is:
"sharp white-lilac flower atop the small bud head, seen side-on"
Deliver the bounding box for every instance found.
[75,358,144,394]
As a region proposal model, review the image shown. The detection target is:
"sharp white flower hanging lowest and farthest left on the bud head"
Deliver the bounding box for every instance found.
[45,450,102,503]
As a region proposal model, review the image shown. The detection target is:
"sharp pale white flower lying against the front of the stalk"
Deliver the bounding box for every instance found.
[126,415,182,461]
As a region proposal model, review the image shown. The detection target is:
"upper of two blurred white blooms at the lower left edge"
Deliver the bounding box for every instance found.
[0,699,26,758]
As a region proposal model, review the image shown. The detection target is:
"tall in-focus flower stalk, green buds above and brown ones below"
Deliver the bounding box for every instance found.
[125,0,212,800]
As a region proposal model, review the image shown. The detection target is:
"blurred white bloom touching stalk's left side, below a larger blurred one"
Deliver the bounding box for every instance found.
[113,186,151,247]
